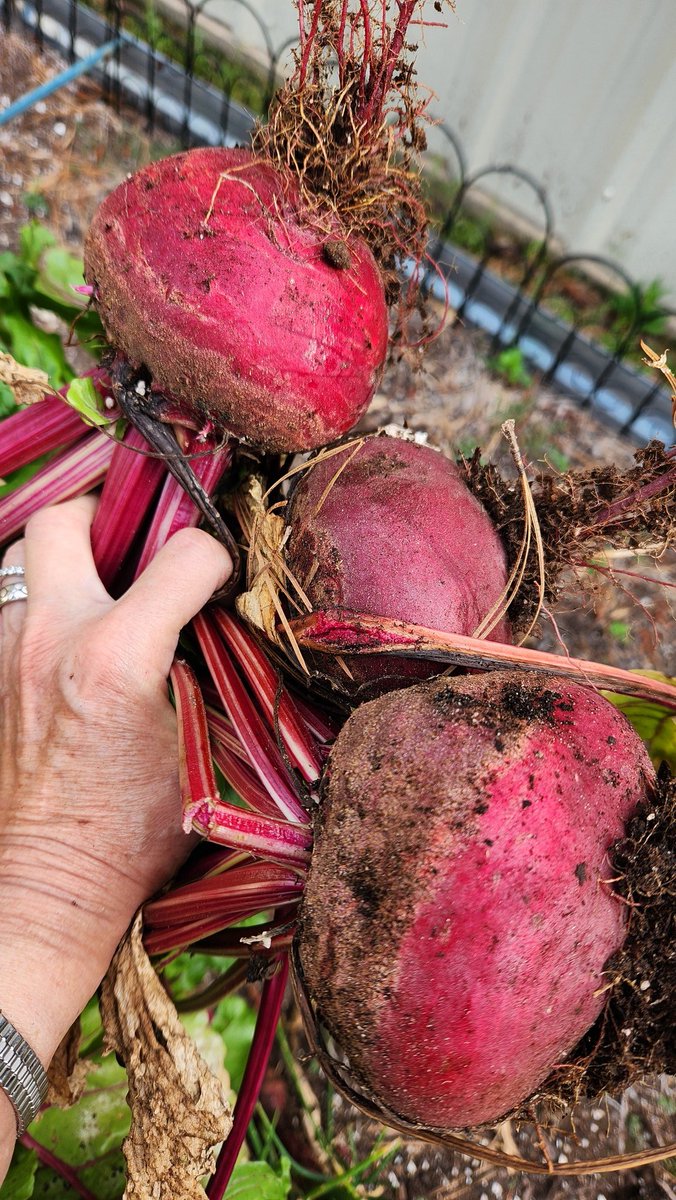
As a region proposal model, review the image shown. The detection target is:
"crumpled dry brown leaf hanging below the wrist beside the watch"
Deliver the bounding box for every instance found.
[101,914,232,1200]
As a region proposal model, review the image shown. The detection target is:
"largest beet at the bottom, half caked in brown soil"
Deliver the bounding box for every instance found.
[298,672,654,1129]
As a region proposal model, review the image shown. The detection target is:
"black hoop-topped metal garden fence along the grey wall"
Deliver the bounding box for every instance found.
[0,0,674,443]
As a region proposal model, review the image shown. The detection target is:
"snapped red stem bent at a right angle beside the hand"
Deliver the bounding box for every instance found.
[171,660,312,866]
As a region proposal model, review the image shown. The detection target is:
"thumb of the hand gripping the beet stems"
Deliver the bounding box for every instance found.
[106,529,233,680]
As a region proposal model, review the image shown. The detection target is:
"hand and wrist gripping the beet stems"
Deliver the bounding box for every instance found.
[0,498,232,1061]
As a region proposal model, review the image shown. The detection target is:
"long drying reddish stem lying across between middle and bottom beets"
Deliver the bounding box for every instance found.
[291,608,676,713]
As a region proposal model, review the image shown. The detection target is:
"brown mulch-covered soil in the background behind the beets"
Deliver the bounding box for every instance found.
[0,25,676,1200]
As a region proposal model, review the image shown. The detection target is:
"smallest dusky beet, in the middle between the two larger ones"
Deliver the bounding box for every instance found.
[286,434,510,682]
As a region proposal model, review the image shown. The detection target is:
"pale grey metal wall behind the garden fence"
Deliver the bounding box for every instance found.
[213,0,676,304]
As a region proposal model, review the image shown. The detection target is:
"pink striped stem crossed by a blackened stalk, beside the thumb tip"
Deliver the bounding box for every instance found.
[136,432,234,576]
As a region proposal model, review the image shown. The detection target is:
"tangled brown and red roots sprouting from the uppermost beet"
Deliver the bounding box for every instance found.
[253,0,454,340]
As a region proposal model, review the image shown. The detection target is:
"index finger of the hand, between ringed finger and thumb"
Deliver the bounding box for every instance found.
[24,496,112,618]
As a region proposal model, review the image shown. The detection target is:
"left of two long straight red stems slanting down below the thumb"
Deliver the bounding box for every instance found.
[192,610,307,824]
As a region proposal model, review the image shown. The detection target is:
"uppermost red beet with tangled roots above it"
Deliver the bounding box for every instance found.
[85,149,388,451]
